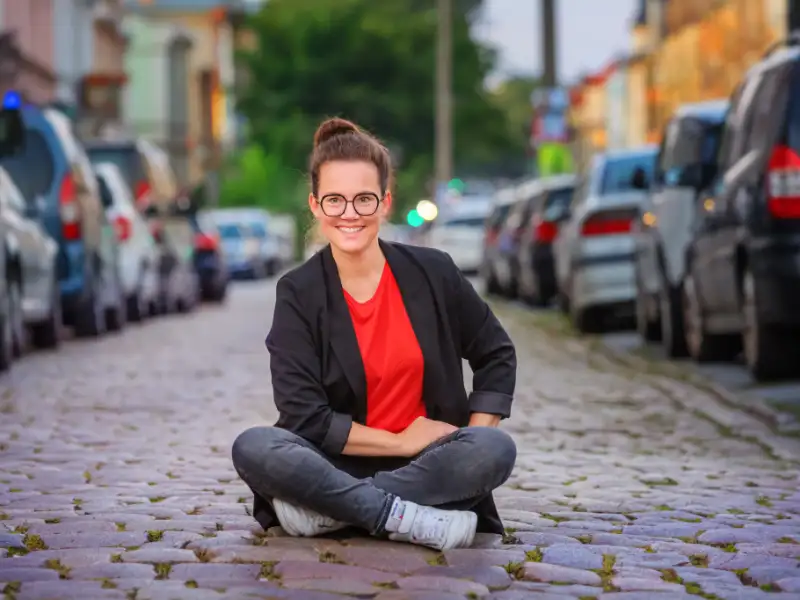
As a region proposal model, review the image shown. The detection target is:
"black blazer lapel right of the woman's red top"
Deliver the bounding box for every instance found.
[380,241,441,418]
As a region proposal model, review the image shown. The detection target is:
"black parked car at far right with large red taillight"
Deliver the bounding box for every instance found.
[682,37,800,380]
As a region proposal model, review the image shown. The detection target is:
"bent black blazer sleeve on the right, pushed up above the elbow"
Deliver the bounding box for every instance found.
[448,256,517,419]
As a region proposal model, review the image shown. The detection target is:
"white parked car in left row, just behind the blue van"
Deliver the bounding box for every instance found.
[94,163,159,321]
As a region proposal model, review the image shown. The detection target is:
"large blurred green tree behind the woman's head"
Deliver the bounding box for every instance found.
[233,0,518,218]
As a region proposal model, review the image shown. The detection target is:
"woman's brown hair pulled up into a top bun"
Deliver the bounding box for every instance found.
[308,117,392,196]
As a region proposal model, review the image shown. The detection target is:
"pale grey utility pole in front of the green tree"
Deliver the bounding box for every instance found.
[436,0,453,191]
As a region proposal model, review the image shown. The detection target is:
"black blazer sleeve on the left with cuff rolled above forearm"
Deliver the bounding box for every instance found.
[266,276,353,456]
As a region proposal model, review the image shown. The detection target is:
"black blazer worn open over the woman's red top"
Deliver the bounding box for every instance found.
[253,241,517,533]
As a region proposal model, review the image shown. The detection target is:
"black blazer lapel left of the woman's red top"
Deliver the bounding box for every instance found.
[321,246,367,423]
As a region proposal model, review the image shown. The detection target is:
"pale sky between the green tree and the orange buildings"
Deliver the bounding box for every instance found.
[475,0,637,85]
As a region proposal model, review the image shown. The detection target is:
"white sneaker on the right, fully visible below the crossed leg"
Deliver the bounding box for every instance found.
[386,499,478,550]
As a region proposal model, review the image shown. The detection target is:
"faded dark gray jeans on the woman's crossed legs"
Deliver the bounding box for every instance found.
[232,427,517,535]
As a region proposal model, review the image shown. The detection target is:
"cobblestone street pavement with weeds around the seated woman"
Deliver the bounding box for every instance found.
[0,284,800,600]
